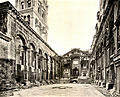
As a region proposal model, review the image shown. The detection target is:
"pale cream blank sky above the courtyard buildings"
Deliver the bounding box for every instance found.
[0,0,99,55]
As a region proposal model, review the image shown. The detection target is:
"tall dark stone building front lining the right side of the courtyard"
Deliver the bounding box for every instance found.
[89,0,120,94]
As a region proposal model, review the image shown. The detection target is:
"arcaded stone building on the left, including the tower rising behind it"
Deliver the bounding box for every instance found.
[0,0,60,88]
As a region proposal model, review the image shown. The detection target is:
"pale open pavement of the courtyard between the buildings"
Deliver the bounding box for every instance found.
[10,84,105,97]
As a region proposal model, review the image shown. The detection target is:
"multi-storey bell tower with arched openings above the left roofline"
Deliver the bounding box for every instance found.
[15,0,48,42]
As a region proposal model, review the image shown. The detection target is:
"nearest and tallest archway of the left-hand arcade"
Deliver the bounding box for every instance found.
[16,35,27,82]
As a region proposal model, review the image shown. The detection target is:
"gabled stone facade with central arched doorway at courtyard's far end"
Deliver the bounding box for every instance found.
[62,48,89,82]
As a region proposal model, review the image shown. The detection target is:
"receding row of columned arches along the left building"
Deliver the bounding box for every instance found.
[15,34,54,82]
